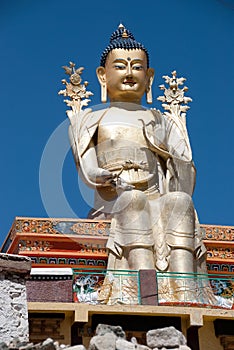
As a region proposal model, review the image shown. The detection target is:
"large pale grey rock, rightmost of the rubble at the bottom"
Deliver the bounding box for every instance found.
[146,327,186,349]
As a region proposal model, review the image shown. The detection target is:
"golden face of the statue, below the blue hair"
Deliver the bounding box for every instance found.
[97,49,153,103]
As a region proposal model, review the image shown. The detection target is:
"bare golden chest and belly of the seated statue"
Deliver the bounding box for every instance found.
[97,109,158,184]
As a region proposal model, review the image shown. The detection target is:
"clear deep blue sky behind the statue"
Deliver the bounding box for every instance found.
[0,0,234,244]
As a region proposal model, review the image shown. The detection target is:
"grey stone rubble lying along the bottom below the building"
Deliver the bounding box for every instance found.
[0,324,191,350]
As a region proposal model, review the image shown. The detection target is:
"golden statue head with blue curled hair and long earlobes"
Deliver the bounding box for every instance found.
[97,24,154,103]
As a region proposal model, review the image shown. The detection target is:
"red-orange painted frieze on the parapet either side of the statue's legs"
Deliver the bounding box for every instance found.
[1,217,234,273]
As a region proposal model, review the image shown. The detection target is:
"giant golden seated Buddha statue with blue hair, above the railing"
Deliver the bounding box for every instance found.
[66,25,205,273]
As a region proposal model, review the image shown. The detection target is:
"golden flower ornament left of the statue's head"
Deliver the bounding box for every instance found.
[58,62,93,113]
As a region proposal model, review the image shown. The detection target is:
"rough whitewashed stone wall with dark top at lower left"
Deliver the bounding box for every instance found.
[0,254,31,343]
